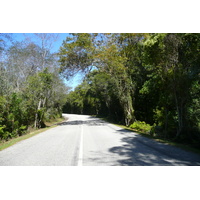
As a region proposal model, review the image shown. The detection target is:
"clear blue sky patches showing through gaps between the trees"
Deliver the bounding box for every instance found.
[13,33,82,89]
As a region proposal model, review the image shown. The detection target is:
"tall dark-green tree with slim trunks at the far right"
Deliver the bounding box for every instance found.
[144,34,199,141]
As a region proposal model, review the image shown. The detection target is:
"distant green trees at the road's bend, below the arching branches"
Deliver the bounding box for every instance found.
[63,70,124,122]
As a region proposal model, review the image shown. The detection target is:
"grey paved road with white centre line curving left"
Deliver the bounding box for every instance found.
[0,114,200,166]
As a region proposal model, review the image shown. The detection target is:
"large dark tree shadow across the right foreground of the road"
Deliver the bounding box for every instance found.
[109,129,200,166]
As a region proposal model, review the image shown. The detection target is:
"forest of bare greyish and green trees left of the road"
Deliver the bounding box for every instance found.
[0,33,68,140]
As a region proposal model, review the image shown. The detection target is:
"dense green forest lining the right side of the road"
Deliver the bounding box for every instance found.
[59,33,200,147]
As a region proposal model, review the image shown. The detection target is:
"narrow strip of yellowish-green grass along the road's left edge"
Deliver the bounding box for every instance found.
[0,118,64,151]
